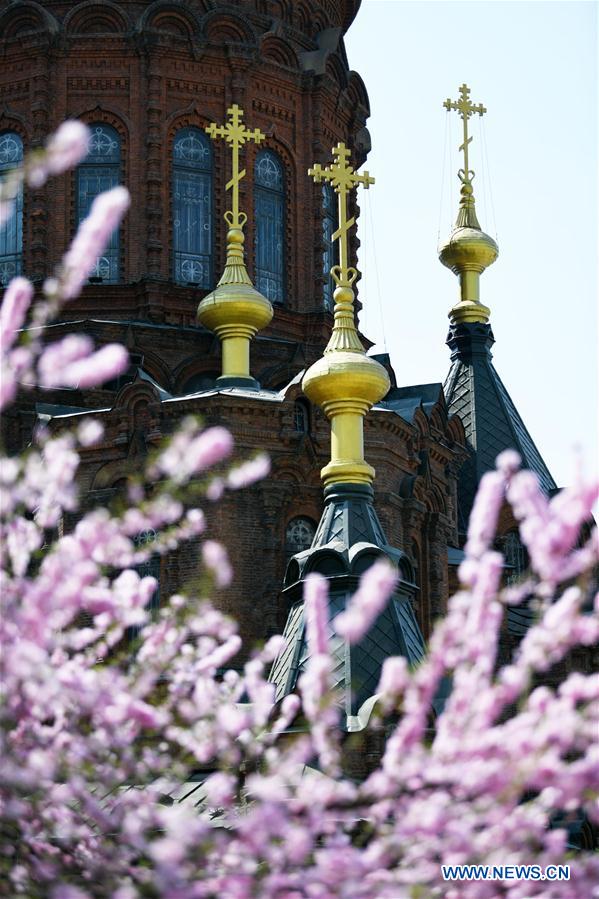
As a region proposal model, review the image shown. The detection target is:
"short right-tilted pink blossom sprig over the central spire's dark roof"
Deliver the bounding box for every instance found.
[333,559,397,643]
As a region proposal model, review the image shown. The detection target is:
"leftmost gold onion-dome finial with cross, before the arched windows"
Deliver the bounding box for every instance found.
[198,104,273,386]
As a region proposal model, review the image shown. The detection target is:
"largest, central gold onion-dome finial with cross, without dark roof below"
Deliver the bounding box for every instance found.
[302,143,389,486]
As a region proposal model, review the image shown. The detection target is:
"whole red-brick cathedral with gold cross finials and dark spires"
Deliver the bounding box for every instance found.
[0,0,556,716]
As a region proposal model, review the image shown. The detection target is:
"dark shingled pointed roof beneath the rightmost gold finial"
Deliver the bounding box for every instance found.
[445,322,556,530]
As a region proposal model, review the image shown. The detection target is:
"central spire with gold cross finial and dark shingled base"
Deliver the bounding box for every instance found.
[269,143,424,731]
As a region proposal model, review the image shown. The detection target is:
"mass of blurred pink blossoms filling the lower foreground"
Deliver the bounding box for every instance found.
[0,243,599,899]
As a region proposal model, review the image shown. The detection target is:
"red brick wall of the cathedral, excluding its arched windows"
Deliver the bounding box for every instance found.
[0,0,463,656]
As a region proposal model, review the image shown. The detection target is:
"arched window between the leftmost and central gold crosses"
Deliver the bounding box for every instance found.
[254,150,285,303]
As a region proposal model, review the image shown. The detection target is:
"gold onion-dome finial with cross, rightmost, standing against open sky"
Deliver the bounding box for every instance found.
[439,84,499,323]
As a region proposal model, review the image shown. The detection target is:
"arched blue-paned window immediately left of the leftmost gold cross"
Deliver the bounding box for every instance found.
[173,128,212,288]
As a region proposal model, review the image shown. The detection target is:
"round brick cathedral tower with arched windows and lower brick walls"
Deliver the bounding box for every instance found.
[0,0,464,660]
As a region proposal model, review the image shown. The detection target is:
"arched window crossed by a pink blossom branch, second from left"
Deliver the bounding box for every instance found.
[77,122,121,284]
